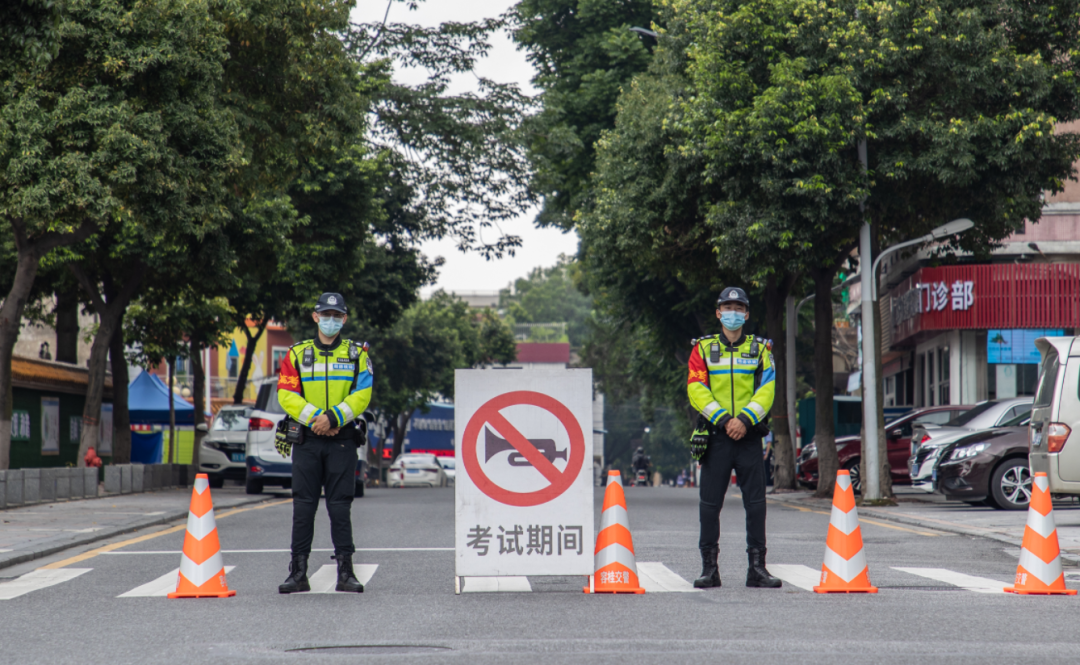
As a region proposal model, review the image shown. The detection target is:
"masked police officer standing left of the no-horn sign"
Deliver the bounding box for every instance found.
[278,294,373,594]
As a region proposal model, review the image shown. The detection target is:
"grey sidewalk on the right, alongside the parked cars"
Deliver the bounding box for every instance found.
[769,486,1080,565]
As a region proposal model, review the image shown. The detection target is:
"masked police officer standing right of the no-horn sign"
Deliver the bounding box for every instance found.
[687,287,781,588]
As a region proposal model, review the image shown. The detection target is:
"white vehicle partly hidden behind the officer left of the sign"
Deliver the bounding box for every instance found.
[244,381,373,497]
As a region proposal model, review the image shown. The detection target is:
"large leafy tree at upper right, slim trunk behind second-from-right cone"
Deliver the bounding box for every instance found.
[675,0,1080,494]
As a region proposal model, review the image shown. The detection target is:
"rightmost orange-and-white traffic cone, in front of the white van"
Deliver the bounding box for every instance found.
[1005,471,1077,596]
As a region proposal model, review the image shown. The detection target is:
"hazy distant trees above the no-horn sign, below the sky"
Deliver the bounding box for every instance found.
[499,255,592,349]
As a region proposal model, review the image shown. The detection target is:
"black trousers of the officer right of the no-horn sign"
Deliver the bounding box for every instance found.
[698,432,765,549]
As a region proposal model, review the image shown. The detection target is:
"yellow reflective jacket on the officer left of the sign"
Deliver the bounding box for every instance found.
[278,336,374,428]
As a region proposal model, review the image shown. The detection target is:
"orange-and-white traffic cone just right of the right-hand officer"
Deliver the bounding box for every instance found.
[813,470,877,594]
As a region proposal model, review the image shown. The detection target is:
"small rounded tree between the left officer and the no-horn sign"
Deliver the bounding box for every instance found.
[347,291,516,475]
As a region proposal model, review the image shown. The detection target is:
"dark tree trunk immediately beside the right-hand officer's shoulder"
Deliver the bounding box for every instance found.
[765,276,795,490]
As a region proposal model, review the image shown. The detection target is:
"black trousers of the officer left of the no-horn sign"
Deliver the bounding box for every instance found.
[293,435,356,555]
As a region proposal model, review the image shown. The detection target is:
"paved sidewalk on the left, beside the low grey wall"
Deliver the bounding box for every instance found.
[0,487,280,569]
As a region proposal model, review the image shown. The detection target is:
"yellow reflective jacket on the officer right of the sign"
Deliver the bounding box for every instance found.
[686,335,777,429]
